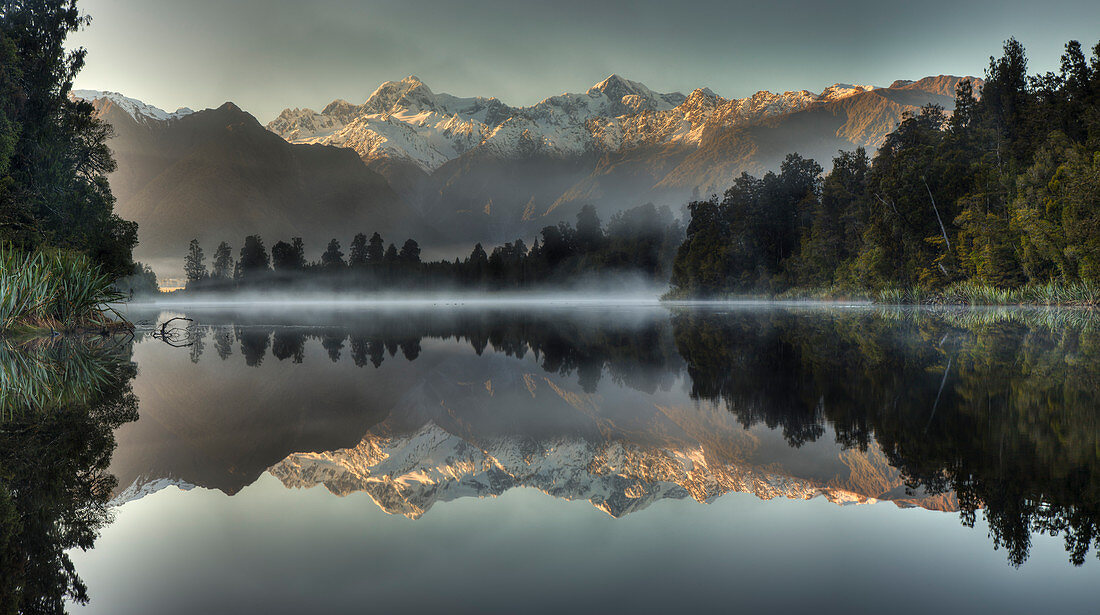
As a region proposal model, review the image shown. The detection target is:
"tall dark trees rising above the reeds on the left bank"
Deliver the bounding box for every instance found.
[0,0,138,277]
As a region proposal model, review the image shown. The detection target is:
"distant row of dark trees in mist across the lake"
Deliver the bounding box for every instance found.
[184,204,683,290]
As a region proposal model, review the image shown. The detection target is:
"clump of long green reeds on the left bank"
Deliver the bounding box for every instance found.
[0,245,123,332]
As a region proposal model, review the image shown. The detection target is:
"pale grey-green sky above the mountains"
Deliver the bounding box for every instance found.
[69,0,1100,122]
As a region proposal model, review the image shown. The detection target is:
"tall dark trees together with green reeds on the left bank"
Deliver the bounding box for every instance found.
[0,0,149,332]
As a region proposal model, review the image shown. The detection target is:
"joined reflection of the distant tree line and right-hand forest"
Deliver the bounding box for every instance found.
[178,308,1100,565]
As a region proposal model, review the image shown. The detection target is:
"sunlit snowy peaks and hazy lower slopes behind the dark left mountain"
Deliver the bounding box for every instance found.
[267,75,980,240]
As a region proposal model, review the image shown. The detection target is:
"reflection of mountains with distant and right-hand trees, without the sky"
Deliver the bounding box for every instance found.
[105,306,1100,565]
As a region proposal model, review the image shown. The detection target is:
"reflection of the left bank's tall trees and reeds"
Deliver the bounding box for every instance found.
[0,339,138,613]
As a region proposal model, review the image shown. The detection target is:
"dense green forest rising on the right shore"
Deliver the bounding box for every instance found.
[671,39,1100,303]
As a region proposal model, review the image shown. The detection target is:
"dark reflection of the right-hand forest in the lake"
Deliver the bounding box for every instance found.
[674,310,1100,565]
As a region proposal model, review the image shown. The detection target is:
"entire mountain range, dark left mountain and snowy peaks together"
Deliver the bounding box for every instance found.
[75,75,982,272]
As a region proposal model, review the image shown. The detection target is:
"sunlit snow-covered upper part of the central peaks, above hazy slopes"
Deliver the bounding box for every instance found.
[267,75,875,173]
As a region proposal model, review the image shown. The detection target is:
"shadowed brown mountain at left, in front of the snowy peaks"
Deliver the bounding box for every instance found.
[76,91,413,272]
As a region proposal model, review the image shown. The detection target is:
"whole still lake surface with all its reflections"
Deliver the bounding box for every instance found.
[0,304,1100,614]
